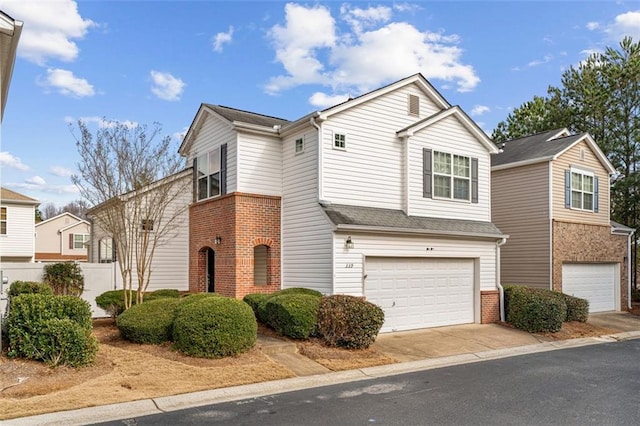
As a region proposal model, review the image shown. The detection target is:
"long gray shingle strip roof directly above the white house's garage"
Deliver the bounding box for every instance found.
[322,204,505,238]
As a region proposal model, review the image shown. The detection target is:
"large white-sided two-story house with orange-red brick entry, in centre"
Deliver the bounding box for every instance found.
[179,74,507,331]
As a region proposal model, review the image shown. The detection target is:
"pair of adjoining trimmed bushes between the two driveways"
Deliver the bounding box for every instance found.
[504,285,589,333]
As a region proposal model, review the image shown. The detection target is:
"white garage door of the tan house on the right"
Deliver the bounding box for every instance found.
[562,263,618,312]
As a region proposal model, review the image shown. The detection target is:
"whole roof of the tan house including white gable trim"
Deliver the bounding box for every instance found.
[491,129,615,173]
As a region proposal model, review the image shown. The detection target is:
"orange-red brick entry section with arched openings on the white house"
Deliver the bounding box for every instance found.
[189,192,280,299]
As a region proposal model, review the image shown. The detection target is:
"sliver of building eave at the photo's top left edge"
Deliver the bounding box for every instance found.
[0,10,22,123]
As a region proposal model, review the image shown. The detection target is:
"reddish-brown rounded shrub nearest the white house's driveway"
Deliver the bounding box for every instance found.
[318,294,384,349]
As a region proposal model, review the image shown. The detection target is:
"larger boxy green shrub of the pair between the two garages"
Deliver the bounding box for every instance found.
[504,286,567,333]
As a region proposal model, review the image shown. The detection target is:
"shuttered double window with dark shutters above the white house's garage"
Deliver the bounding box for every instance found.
[422,148,478,203]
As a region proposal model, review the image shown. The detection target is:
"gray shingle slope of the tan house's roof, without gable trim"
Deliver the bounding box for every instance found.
[491,129,584,166]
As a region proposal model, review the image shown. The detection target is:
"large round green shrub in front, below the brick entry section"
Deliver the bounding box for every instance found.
[173,296,258,358]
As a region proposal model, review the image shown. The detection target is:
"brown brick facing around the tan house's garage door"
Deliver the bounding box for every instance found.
[552,220,628,310]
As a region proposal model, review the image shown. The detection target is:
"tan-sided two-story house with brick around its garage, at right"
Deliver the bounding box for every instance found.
[491,129,634,312]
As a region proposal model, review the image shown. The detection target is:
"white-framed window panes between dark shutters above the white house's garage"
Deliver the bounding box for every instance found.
[433,151,471,201]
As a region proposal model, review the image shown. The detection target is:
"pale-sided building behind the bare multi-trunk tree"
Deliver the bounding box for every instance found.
[87,168,192,291]
